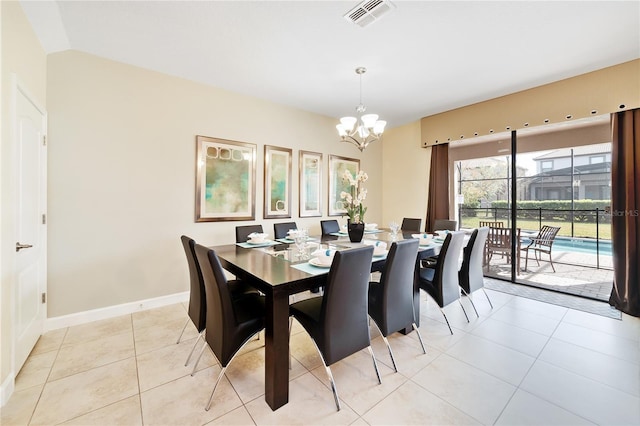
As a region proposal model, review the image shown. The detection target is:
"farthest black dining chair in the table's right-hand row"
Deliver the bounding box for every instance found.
[458,226,493,315]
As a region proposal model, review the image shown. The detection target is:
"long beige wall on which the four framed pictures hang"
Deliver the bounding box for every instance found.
[47,51,382,317]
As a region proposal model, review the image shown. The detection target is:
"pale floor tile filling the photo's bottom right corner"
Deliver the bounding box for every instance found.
[520,361,640,425]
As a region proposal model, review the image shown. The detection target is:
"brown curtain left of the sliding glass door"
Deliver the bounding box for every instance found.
[425,144,449,231]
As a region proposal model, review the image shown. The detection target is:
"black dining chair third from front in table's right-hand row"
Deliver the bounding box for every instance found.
[418,231,469,334]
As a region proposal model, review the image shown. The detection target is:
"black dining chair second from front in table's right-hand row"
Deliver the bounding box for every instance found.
[369,239,427,372]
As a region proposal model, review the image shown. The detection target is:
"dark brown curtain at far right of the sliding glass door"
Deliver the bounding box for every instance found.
[609,109,640,317]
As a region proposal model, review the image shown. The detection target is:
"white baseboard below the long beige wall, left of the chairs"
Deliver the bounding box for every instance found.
[44,291,189,333]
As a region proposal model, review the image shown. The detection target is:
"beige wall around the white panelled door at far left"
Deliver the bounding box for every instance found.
[0,1,47,400]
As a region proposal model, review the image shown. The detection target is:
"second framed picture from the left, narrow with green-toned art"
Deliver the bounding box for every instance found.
[264,145,292,219]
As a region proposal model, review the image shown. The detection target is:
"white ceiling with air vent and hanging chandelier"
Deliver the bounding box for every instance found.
[21,0,640,127]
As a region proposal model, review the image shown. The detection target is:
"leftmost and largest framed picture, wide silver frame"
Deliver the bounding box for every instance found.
[196,136,256,222]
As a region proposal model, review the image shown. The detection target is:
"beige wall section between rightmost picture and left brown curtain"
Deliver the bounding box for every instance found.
[382,121,431,230]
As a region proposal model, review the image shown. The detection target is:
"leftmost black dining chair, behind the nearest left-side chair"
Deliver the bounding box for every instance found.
[176,235,258,375]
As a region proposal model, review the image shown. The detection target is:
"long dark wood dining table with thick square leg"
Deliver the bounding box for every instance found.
[210,231,437,410]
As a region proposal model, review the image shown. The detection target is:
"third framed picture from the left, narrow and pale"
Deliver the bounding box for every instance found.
[298,151,322,217]
